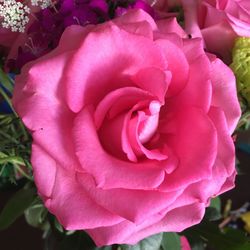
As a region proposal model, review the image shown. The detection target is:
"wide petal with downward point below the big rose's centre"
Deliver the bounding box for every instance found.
[77,173,181,225]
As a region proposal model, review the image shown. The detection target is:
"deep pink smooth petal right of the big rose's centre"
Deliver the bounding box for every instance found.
[159,106,217,191]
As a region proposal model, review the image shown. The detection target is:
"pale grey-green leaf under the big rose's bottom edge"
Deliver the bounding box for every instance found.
[121,233,163,250]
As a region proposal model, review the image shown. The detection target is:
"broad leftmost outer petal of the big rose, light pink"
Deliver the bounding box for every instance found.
[13,52,78,172]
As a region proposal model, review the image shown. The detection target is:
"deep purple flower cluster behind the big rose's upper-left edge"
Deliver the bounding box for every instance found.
[7,0,109,69]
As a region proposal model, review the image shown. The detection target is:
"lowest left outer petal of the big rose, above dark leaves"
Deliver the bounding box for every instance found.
[45,165,123,230]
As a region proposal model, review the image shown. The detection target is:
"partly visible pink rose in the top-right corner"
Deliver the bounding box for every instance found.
[199,0,250,62]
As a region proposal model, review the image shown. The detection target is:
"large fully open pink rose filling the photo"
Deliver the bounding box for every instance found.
[13,10,240,246]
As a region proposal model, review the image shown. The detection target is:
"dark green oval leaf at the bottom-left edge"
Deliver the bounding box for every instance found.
[0,189,36,230]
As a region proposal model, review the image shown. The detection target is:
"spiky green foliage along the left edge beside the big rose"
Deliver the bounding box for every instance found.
[0,69,32,187]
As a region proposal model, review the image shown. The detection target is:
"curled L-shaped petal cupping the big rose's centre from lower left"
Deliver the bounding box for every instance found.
[73,105,165,189]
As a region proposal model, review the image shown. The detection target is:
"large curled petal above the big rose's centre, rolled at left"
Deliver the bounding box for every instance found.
[65,23,165,112]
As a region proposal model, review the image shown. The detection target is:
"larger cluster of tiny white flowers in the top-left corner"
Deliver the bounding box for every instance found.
[0,0,30,32]
